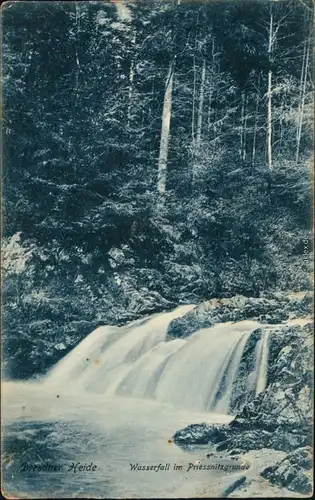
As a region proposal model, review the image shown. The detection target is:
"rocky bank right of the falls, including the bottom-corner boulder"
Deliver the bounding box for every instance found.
[174,324,313,494]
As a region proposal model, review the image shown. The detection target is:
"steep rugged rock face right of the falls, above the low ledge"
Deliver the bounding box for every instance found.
[233,324,313,432]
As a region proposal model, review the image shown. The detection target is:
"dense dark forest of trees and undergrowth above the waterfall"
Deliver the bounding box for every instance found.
[2,0,314,378]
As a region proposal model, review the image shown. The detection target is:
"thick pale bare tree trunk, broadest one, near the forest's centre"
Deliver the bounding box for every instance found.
[157,61,174,201]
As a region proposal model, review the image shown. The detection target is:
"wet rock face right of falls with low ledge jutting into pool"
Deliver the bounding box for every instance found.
[173,325,313,460]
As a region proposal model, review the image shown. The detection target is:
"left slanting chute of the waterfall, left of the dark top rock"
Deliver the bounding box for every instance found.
[45,305,195,393]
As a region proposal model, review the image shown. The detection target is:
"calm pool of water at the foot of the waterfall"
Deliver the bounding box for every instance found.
[2,382,239,498]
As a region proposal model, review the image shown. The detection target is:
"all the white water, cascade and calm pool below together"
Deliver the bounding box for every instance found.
[3,305,276,498]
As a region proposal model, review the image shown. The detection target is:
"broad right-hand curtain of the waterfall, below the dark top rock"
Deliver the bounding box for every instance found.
[155,321,257,413]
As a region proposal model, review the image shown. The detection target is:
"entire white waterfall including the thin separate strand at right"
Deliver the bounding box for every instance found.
[44,305,268,414]
